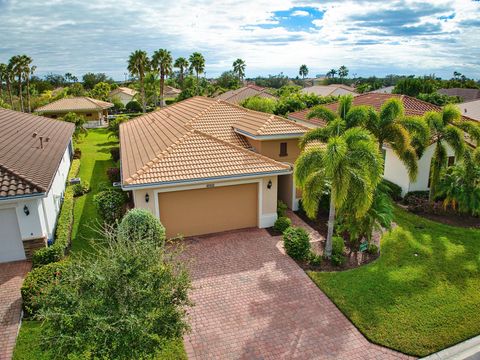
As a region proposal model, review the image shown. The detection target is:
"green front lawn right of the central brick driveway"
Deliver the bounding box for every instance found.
[309,209,480,356]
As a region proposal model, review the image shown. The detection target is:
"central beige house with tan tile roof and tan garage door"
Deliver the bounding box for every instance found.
[120,97,308,236]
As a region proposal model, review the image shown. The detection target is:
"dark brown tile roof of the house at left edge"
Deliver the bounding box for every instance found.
[0,109,75,198]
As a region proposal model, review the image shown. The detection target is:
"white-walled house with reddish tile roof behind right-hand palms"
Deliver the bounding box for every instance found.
[288,93,470,194]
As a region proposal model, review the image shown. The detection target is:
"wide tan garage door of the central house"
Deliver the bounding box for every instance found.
[158,183,258,237]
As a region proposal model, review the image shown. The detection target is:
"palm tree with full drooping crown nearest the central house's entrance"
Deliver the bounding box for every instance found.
[294,123,383,257]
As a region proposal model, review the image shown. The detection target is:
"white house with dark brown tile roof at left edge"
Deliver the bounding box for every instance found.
[0,109,75,262]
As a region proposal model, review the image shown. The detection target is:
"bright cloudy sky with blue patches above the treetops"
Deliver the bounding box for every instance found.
[0,0,480,80]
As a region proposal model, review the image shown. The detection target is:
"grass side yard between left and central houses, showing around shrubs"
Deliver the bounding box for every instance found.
[13,129,186,360]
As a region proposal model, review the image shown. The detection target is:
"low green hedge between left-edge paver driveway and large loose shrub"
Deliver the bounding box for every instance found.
[21,261,69,316]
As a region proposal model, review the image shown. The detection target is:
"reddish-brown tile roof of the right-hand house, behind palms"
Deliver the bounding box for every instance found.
[288,93,441,126]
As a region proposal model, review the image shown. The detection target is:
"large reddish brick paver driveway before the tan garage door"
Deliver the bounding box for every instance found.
[184,229,407,359]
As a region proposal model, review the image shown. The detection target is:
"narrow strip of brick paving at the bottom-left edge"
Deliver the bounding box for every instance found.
[0,261,30,360]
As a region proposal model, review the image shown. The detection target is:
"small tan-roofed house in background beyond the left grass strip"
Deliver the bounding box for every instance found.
[35,97,113,125]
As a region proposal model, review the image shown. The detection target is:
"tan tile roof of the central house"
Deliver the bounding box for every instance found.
[120,97,308,185]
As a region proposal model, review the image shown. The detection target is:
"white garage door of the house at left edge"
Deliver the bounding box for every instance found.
[0,209,25,262]
